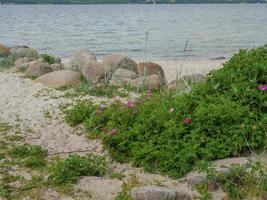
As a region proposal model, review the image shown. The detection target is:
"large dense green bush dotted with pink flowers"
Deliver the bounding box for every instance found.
[64,46,267,177]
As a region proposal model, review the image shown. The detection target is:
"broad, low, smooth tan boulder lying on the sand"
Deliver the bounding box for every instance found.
[35,70,81,88]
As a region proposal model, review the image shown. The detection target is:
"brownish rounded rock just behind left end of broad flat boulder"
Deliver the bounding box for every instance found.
[25,59,52,77]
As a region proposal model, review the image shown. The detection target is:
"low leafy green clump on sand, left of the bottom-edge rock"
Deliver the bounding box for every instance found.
[49,154,107,186]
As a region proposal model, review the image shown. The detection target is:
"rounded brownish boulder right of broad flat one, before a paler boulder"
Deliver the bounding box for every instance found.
[81,62,105,84]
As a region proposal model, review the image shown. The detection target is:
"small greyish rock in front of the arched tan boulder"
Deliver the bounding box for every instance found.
[110,68,137,86]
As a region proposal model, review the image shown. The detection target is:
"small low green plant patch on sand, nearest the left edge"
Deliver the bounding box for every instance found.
[9,144,46,169]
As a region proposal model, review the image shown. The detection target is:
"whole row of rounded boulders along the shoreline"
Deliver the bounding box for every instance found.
[0,44,205,90]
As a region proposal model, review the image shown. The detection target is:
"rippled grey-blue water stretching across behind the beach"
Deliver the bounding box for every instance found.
[0,4,267,59]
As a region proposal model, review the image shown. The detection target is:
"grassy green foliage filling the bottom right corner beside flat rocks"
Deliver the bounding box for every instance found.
[200,162,267,200]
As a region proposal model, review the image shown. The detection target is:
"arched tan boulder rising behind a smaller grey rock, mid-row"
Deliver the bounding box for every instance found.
[102,54,138,74]
